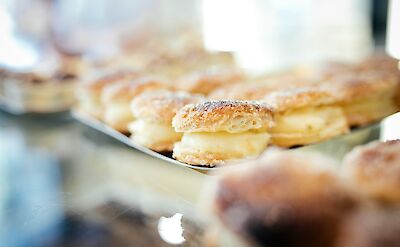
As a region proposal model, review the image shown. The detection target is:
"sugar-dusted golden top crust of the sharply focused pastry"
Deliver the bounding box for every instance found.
[172,100,273,133]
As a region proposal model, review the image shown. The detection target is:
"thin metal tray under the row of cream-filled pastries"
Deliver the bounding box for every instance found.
[72,110,400,172]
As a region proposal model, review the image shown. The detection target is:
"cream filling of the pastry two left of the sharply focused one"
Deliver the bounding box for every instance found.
[104,103,133,128]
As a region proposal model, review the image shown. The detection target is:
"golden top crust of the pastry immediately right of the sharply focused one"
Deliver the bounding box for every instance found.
[263,86,337,112]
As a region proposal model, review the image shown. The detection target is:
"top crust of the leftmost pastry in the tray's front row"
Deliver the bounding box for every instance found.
[82,70,140,92]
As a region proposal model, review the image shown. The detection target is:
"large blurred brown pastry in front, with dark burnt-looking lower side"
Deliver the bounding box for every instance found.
[213,152,359,247]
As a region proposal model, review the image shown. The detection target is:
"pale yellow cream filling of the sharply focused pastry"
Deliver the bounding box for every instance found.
[174,131,270,158]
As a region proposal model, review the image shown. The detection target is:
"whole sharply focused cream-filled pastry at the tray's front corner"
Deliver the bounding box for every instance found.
[172,100,273,166]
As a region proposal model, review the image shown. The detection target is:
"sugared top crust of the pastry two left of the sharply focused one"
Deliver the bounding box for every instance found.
[102,76,167,104]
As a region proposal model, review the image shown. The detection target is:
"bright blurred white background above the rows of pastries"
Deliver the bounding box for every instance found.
[0,0,387,72]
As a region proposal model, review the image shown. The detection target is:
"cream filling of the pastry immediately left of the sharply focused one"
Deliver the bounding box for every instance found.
[128,119,182,146]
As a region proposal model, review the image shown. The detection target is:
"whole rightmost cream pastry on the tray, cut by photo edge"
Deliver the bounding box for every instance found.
[325,71,398,127]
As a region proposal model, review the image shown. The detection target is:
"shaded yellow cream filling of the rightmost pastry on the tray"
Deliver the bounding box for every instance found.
[342,97,397,124]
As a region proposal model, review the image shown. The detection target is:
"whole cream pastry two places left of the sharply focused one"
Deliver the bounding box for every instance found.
[101,76,167,133]
